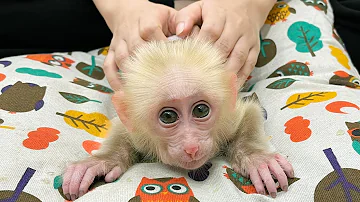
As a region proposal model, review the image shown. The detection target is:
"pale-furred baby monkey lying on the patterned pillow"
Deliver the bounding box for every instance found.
[62,37,294,200]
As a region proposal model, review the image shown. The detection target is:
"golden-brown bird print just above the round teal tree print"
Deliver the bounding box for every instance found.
[265,1,296,25]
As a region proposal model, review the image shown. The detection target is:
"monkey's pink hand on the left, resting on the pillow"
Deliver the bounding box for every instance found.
[62,157,125,201]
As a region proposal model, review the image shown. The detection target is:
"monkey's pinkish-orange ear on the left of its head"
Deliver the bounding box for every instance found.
[111,90,133,132]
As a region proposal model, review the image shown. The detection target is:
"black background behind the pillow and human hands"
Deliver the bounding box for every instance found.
[0,0,360,68]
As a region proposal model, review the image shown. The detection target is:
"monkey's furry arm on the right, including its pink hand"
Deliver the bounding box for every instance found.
[228,101,294,197]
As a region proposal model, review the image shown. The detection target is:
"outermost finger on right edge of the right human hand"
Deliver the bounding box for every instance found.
[237,48,259,85]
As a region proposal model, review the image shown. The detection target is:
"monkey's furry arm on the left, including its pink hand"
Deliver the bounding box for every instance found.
[62,118,136,200]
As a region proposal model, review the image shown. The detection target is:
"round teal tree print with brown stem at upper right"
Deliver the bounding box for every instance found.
[287,21,323,57]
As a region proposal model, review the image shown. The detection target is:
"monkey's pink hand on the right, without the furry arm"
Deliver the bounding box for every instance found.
[232,153,294,198]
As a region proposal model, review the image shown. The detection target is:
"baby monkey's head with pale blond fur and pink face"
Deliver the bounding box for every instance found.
[113,38,238,169]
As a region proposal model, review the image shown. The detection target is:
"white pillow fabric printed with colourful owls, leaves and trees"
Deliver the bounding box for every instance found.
[0,0,360,202]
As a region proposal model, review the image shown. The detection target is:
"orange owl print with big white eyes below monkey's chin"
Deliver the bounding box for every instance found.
[129,177,199,202]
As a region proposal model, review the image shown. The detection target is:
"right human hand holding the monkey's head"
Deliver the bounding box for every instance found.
[172,0,276,85]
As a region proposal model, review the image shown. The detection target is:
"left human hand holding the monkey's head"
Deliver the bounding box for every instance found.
[94,0,176,90]
